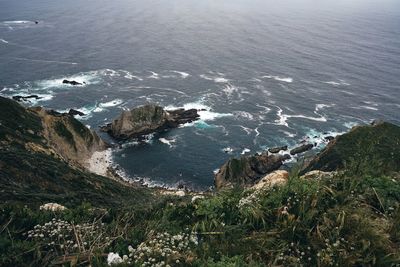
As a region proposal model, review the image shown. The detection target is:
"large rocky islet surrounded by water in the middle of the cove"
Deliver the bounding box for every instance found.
[101,104,199,140]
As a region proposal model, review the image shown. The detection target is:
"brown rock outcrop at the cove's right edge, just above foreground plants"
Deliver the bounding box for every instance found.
[214,152,290,189]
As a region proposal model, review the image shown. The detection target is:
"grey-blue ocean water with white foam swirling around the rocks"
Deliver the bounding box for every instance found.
[0,0,400,189]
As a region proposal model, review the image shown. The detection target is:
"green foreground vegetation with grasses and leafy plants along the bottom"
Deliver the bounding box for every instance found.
[0,165,400,266]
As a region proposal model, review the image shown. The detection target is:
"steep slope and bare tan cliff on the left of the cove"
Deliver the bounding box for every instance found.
[0,97,148,206]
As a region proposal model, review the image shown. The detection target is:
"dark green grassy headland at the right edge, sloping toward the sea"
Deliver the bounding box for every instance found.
[301,122,400,174]
